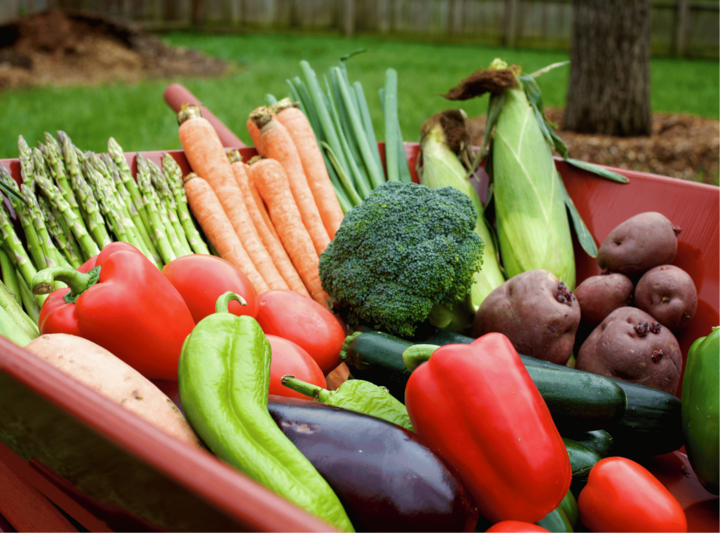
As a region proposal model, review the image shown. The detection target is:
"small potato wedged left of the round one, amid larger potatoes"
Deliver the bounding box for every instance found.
[575,274,634,329]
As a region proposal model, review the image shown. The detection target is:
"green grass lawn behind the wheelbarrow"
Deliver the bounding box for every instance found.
[0,33,720,157]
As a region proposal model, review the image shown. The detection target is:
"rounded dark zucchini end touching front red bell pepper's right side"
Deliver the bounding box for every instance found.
[525,365,626,434]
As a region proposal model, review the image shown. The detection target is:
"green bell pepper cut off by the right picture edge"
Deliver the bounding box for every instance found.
[680,327,720,495]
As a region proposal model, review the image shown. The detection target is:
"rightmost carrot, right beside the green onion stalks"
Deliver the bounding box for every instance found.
[273,98,344,240]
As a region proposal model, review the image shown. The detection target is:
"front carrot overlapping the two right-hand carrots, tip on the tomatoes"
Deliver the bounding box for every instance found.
[252,159,330,307]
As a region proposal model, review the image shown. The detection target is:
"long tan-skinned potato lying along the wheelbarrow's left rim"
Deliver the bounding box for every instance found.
[25,334,203,448]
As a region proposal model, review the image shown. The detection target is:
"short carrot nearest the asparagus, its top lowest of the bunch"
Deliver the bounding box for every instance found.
[184,173,269,294]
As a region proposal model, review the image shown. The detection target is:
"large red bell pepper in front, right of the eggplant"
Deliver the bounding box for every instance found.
[405,333,572,523]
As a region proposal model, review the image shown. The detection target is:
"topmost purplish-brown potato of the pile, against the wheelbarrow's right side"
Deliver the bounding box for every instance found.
[597,212,680,278]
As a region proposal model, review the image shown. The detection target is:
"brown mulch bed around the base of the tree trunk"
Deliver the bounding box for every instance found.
[468,108,720,184]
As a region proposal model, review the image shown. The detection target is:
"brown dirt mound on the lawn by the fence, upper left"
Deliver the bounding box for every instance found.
[0,10,228,88]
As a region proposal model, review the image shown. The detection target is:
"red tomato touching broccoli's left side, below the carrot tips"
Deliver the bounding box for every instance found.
[256,290,345,375]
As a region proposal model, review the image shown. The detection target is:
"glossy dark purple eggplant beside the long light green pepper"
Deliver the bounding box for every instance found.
[268,396,478,532]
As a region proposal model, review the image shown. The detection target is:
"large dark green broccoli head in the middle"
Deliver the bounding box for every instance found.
[320,182,483,336]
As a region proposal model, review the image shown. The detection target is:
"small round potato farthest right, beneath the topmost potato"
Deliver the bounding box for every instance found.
[635,264,697,332]
